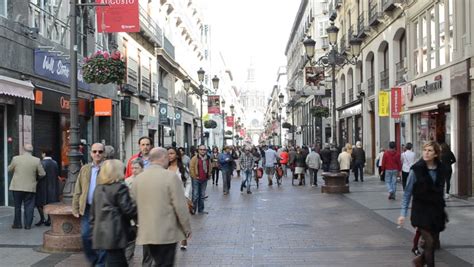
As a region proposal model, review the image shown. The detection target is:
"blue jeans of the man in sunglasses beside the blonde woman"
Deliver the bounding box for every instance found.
[81,204,106,267]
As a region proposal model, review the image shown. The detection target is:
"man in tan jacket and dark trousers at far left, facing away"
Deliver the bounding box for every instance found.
[8,144,46,229]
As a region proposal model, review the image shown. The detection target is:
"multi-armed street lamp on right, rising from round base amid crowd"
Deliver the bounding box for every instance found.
[303,21,362,171]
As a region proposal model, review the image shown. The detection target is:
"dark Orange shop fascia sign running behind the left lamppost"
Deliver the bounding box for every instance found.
[35,89,89,116]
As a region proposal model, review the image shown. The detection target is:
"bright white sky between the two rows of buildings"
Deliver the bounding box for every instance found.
[202,0,300,96]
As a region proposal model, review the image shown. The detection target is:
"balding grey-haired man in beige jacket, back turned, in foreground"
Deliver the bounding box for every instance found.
[132,147,191,266]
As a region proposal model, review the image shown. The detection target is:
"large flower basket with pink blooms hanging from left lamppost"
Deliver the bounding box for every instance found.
[82,51,126,85]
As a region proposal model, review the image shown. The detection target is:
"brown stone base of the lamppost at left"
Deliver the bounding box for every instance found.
[42,203,82,253]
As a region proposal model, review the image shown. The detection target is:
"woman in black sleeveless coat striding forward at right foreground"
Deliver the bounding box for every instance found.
[398,141,448,266]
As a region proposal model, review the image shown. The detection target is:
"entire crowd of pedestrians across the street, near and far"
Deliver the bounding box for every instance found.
[8,136,456,266]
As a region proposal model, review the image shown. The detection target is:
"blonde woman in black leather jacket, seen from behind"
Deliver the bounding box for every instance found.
[90,159,137,267]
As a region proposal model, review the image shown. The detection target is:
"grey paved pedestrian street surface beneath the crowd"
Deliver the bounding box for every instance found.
[0,173,474,267]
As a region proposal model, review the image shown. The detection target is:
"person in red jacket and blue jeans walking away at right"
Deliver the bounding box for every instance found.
[382,141,402,200]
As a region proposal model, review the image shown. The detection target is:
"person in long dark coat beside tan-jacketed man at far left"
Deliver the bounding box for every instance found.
[35,149,61,226]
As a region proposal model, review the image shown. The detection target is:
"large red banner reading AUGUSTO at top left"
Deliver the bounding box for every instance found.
[95,0,140,32]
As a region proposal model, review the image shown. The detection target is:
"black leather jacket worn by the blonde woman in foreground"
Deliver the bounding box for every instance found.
[90,183,137,249]
